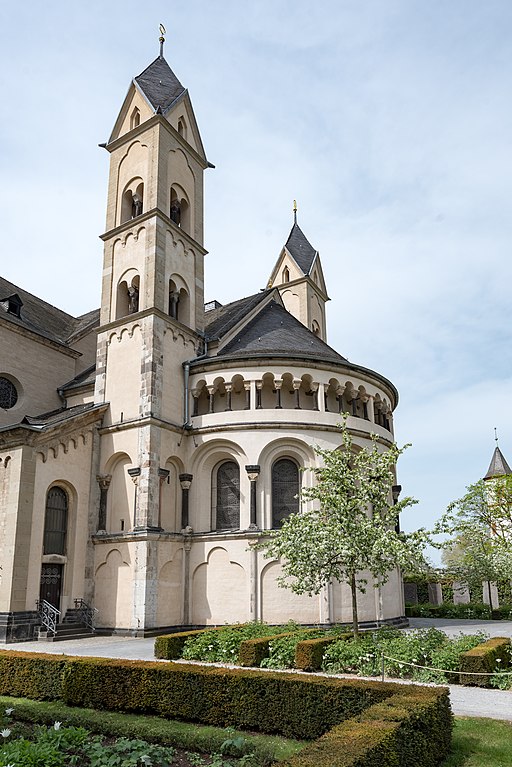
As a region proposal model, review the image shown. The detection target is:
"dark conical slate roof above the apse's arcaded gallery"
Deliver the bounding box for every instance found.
[211,300,347,364]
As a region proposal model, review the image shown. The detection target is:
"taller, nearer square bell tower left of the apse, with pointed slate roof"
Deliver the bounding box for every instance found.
[95,36,209,530]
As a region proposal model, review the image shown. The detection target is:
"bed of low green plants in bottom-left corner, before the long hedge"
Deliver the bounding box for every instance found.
[0,697,302,767]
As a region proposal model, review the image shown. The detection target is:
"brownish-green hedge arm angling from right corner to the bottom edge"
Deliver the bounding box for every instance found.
[281,688,452,767]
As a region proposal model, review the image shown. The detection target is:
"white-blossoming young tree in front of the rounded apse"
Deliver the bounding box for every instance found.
[260,422,426,636]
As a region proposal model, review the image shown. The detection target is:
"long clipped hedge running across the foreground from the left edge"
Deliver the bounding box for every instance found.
[0,651,451,756]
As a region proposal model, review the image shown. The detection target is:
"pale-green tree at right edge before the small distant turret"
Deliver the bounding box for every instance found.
[433,476,512,610]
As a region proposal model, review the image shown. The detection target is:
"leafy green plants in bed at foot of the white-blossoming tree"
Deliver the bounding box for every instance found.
[322,628,487,684]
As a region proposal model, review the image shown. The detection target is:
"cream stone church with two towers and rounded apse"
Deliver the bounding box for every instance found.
[0,43,404,642]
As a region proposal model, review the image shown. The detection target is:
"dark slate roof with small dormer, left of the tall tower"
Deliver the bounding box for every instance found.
[0,277,100,346]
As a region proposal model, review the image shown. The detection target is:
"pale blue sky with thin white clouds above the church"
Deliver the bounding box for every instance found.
[0,0,512,561]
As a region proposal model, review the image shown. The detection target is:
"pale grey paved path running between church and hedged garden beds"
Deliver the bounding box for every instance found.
[0,618,512,722]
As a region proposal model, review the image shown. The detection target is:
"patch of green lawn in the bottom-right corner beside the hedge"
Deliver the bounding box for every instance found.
[442,717,512,767]
